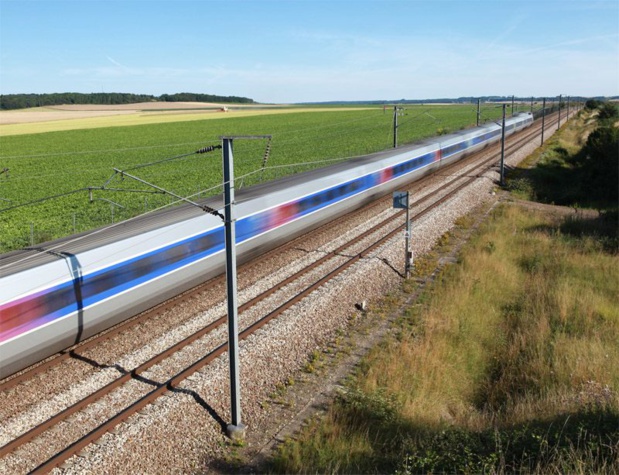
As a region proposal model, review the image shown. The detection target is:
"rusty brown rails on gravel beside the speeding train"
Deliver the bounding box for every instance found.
[0,109,576,472]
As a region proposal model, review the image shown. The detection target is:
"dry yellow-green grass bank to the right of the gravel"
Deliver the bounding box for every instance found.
[271,109,619,473]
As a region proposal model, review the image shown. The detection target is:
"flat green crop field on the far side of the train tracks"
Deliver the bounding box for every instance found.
[0,104,520,252]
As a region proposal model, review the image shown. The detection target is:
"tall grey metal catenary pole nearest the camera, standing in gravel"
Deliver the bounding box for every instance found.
[222,137,245,439]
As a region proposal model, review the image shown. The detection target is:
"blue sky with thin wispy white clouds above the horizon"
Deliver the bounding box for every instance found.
[0,0,619,103]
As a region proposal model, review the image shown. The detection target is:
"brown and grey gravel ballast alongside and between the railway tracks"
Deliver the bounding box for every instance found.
[0,123,551,473]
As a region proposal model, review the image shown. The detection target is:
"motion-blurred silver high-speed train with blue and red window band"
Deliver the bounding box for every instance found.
[0,113,533,378]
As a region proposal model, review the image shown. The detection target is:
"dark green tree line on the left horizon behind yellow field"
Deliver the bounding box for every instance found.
[0,92,254,110]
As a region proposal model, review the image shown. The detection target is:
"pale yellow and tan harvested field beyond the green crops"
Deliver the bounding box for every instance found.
[0,102,368,137]
